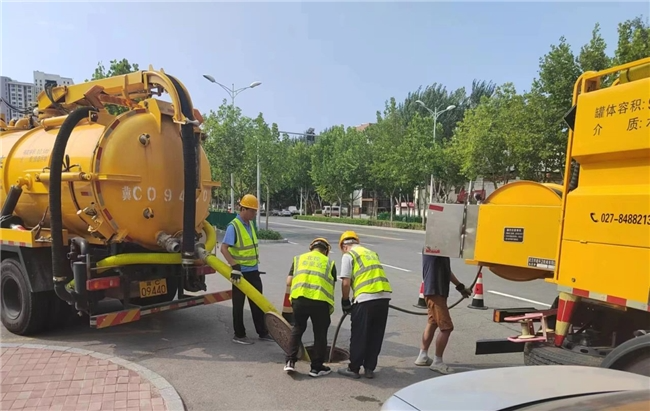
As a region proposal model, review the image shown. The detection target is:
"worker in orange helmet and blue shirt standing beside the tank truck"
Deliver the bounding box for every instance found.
[221,194,273,344]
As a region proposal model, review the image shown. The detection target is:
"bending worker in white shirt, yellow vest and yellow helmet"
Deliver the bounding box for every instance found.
[338,231,393,378]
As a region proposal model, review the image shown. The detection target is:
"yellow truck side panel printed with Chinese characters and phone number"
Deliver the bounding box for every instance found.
[556,69,650,307]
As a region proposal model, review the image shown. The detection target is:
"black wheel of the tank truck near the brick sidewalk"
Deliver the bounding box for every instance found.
[0,258,48,335]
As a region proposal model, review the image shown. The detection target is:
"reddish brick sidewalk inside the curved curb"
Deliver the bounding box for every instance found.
[0,346,180,411]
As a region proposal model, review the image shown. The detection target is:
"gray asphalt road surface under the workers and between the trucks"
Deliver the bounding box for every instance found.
[0,217,556,410]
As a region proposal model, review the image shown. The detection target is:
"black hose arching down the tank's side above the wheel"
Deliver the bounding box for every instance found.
[49,107,97,304]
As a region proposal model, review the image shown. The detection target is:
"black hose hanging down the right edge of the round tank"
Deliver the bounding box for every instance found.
[167,75,198,264]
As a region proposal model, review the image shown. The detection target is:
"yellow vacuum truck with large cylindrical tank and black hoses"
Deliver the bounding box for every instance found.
[0,67,277,335]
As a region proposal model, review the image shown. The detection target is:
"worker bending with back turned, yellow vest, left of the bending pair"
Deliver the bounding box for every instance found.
[284,238,336,377]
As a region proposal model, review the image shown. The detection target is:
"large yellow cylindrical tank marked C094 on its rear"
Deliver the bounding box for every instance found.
[0,109,212,250]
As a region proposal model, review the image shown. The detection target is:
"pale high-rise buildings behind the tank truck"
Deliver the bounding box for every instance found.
[0,71,74,122]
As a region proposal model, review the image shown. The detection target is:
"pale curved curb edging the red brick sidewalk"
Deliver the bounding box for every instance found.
[0,342,186,411]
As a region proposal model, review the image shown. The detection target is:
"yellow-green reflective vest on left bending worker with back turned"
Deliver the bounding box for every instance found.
[289,250,334,314]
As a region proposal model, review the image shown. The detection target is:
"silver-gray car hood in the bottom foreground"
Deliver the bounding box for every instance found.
[382,365,650,411]
